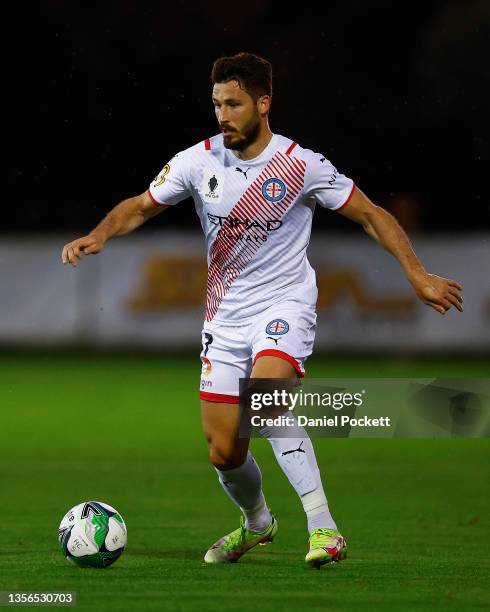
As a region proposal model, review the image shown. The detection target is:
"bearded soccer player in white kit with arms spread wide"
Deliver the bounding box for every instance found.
[62,53,463,567]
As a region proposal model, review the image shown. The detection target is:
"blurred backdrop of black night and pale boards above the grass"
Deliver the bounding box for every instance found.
[0,1,490,355]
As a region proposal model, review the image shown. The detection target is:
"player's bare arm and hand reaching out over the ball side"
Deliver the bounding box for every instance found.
[61,191,168,268]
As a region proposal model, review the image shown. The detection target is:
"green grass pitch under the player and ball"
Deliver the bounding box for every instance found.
[0,354,490,612]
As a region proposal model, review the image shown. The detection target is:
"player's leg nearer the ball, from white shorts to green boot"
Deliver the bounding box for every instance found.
[200,328,277,563]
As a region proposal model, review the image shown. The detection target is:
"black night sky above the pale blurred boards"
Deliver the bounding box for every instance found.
[1,0,490,234]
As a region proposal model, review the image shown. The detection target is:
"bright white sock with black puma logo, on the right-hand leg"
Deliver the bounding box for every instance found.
[260,424,337,533]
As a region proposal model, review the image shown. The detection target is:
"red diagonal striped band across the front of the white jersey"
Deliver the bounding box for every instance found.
[206,151,306,321]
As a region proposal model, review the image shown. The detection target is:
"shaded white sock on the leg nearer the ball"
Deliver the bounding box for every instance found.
[215,452,271,532]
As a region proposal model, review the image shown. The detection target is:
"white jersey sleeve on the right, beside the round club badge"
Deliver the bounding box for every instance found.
[303,150,354,210]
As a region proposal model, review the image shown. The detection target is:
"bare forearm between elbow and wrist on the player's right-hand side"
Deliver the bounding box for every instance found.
[364,206,426,280]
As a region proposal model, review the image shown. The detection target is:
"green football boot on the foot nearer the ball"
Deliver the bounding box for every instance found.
[204,516,277,563]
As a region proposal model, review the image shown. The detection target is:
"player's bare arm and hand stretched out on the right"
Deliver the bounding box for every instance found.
[339,188,463,314]
